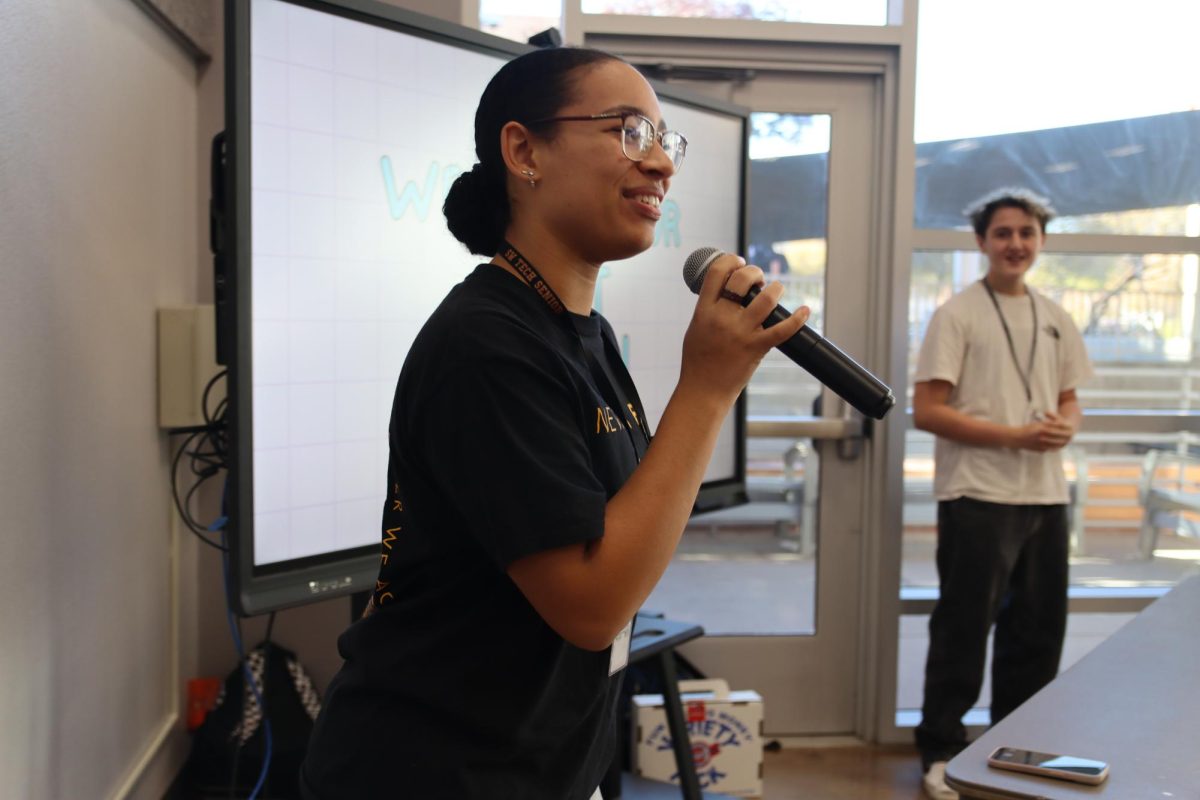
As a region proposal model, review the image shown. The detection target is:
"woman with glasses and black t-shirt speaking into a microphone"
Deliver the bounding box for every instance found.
[302,48,808,800]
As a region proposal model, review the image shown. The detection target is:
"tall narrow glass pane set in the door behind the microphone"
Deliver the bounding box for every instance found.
[646,112,832,636]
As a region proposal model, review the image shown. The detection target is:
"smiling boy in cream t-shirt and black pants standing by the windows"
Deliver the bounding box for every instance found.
[913,190,1092,800]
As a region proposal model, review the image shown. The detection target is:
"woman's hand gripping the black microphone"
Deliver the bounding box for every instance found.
[679,254,809,405]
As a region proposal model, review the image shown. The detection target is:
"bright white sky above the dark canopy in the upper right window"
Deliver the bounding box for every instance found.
[916,0,1200,142]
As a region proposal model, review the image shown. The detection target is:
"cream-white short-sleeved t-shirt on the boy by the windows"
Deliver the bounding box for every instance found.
[914,282,1092,504]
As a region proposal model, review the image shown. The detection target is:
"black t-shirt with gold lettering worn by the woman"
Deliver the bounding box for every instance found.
[304,264,649,800]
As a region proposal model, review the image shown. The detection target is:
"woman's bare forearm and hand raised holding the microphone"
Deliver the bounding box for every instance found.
[508,255,809,650]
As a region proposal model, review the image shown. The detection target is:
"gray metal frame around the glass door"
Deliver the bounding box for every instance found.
[564,21,916,741]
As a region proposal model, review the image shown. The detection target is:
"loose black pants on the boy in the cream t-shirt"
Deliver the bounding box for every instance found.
[916,498,1068,768]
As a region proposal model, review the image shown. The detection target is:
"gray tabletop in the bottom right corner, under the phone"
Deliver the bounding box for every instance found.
[946,576,1200,800]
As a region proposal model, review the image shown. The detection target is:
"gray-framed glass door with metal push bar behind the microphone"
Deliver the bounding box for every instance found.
[646,71,902,736]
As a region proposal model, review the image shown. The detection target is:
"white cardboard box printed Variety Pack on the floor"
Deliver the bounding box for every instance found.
[630,679,762,798]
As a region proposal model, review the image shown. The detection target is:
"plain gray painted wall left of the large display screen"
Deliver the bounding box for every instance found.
[0,0,477,800]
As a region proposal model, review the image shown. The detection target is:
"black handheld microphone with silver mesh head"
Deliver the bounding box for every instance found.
[683,247,896,420]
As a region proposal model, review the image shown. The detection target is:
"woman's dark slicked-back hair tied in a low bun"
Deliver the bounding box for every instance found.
[442,47,620,255]
